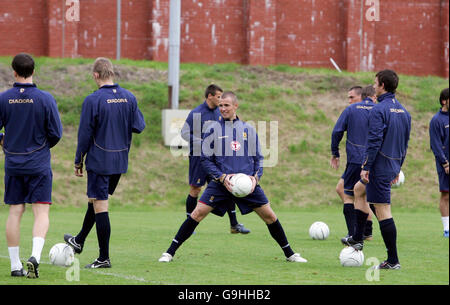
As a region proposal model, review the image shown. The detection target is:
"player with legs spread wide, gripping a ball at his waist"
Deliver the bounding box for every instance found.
[159,92,306,263]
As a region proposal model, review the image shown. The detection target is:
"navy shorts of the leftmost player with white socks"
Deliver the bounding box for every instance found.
[4,170,53,204]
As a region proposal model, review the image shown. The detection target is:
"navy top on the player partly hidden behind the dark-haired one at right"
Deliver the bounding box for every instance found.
[331,98,375,165]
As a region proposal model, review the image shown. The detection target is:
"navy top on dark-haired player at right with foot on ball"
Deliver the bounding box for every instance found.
[363,92,411,175]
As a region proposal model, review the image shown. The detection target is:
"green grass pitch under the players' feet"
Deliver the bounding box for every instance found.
[0,206,449,285]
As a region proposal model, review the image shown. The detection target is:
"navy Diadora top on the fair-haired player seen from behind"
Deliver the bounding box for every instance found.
[75,84,145,175]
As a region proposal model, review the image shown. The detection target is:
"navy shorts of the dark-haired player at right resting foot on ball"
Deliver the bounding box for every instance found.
[366,172,397,204]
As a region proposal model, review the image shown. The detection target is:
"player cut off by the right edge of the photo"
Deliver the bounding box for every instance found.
[430,88,449,238]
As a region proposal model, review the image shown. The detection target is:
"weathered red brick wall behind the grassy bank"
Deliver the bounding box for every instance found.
[0,0,449,77]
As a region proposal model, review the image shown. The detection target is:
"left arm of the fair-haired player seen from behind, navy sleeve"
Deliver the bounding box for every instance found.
[75,99,95,176]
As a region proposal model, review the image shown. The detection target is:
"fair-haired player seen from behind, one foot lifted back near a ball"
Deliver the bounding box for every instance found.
[64,57,145,268]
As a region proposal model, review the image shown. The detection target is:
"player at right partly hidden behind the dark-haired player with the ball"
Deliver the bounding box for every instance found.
[330,86,376,240]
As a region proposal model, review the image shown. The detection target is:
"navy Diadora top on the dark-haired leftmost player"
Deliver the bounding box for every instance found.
[0,83,62,176]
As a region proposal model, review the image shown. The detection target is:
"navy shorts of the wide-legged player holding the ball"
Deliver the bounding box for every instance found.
[199,181,269,216]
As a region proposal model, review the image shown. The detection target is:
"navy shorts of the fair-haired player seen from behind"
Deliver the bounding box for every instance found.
[87,171,121,200]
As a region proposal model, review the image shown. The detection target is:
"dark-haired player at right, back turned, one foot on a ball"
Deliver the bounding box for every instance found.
[347,70,411,269]
